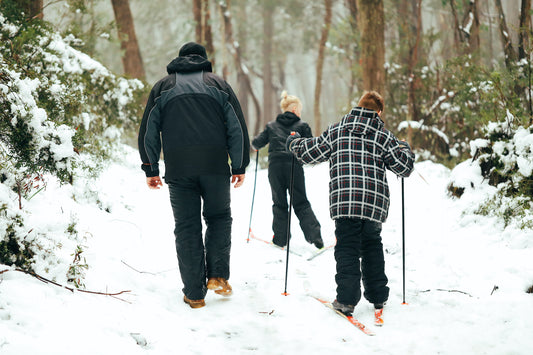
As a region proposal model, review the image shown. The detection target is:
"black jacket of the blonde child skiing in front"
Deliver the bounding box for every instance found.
[252,111,313,162]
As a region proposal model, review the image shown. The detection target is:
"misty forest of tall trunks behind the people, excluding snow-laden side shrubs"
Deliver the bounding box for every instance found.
[39,0,532,167]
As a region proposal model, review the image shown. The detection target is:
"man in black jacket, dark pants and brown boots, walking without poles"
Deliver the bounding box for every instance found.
[138,42,250,308]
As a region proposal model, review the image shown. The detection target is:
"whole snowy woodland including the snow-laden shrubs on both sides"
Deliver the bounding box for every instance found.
[0,0,533,287]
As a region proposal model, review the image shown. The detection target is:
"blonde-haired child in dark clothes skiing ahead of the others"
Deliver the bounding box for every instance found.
[252,91,324,249]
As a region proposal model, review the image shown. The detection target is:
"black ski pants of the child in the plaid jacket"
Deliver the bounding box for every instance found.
[335,218,389,306]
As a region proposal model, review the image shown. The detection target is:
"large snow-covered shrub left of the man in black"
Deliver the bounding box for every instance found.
[0,5,145,286]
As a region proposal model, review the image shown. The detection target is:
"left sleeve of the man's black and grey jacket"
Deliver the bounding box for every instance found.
[137,87,161,177]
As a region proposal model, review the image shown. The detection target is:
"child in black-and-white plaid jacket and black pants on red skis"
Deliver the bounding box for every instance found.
[286,91,414,315]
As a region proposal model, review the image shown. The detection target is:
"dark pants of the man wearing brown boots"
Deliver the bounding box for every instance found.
[168,175,232,300]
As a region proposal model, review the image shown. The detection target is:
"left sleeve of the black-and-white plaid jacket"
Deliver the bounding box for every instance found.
[289,131,331,164]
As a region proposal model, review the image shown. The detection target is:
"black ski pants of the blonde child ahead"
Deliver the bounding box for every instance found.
[268,159,322,246]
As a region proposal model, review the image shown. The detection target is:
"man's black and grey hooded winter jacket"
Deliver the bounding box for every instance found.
[138,55,250,181]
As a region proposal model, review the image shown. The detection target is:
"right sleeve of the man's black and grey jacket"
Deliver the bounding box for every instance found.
[224,83,250,175]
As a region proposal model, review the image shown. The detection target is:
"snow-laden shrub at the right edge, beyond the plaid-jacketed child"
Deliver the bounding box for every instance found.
[448,111,533,228]
